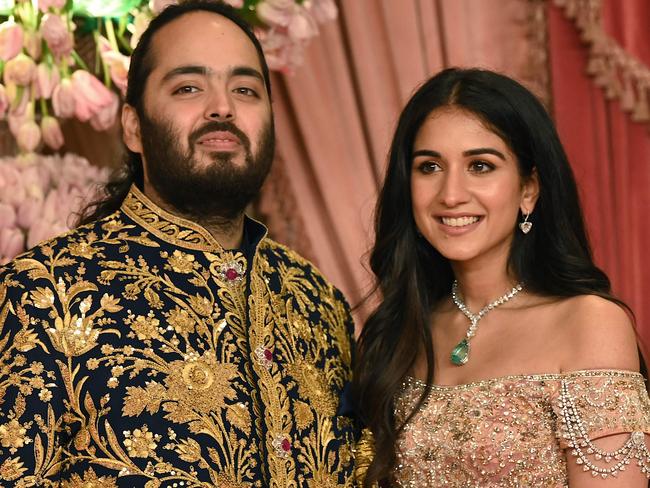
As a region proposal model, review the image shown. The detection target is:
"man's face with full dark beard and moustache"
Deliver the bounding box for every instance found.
[123,12,274,218]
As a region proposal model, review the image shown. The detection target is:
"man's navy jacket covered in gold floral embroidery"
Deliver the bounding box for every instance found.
[0,187,356,488]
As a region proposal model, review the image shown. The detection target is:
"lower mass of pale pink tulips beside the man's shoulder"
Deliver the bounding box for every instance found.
[0,154,109,265]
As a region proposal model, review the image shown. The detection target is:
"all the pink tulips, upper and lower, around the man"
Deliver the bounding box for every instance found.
[0,0,337,265]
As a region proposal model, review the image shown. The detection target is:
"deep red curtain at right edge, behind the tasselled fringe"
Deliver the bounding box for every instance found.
[548,0,650,350]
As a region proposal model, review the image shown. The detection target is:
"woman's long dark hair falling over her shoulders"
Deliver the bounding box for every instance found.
[355,68,627,486]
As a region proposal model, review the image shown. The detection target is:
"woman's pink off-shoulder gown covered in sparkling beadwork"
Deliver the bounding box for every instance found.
[394,370,650,488]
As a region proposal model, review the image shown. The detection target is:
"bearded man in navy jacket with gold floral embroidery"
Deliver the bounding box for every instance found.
[0,2,356,488]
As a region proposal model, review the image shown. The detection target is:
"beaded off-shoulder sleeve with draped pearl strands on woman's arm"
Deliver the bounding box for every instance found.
[553,371,650,478]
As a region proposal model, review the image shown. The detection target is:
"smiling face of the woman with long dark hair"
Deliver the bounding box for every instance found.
[411,107,538,270]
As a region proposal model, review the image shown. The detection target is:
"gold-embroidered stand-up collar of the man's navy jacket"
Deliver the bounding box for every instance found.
[121,185,267,253]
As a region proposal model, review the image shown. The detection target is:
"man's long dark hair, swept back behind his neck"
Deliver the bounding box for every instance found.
[77,0,271,225]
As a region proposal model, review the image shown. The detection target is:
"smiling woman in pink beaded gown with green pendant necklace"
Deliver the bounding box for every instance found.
[355,69,650,488]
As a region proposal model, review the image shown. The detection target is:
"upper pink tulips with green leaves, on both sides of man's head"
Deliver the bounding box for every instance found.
[0,0,337,153]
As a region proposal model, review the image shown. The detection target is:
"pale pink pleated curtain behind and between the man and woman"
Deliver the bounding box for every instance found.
[259,0,547,328]
